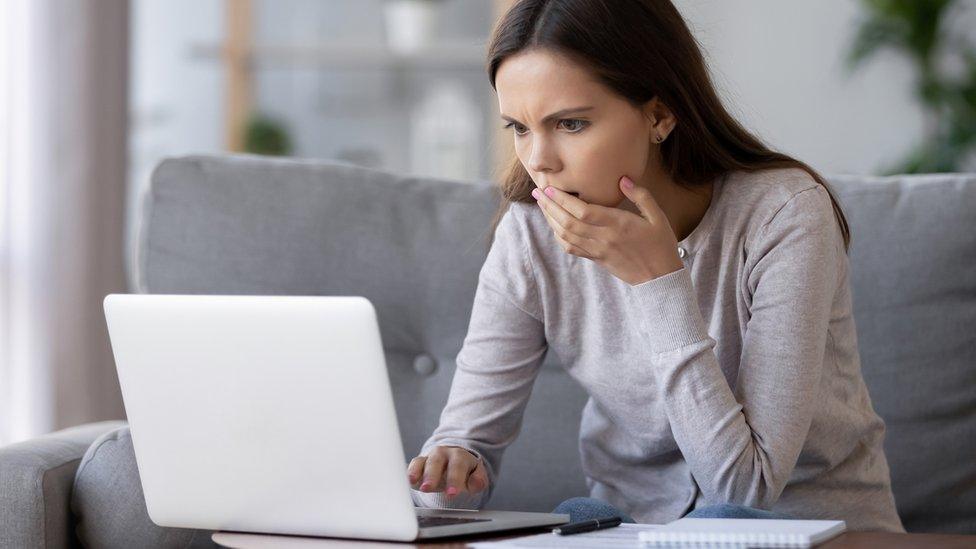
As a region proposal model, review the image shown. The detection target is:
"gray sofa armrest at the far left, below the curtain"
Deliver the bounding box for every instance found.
[0,420,126,548]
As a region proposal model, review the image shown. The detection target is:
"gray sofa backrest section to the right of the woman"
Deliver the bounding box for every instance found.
[828,173,976,534]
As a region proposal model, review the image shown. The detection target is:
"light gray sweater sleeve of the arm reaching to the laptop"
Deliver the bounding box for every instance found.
[411,204,548,509]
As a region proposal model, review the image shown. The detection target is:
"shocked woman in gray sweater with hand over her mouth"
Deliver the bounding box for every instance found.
[408,0,904,532]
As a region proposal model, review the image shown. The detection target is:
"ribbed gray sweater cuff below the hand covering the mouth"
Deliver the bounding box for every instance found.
[630,267,709,353]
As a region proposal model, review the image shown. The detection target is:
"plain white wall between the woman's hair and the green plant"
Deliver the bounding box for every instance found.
[675,0,976,174]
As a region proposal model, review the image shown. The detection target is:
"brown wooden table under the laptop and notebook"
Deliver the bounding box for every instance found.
[213,527,976,549]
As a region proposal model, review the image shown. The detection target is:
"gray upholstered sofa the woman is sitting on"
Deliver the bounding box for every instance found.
[0,155,976,547]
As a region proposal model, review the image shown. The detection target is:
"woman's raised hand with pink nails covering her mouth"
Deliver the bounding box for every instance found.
[532,176,684,286]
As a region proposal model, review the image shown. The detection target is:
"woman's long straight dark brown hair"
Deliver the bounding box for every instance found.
[486,0,851,251]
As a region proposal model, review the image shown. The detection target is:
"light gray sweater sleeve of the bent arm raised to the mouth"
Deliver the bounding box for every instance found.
[630,185,844,509]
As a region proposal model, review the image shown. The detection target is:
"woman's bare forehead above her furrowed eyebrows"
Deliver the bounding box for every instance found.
[495,50,609,117]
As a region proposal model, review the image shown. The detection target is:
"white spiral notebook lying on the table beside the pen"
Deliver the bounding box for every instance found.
[637,518,847,548]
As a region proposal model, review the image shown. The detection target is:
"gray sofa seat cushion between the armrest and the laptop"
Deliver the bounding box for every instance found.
[71,425,217,549]
